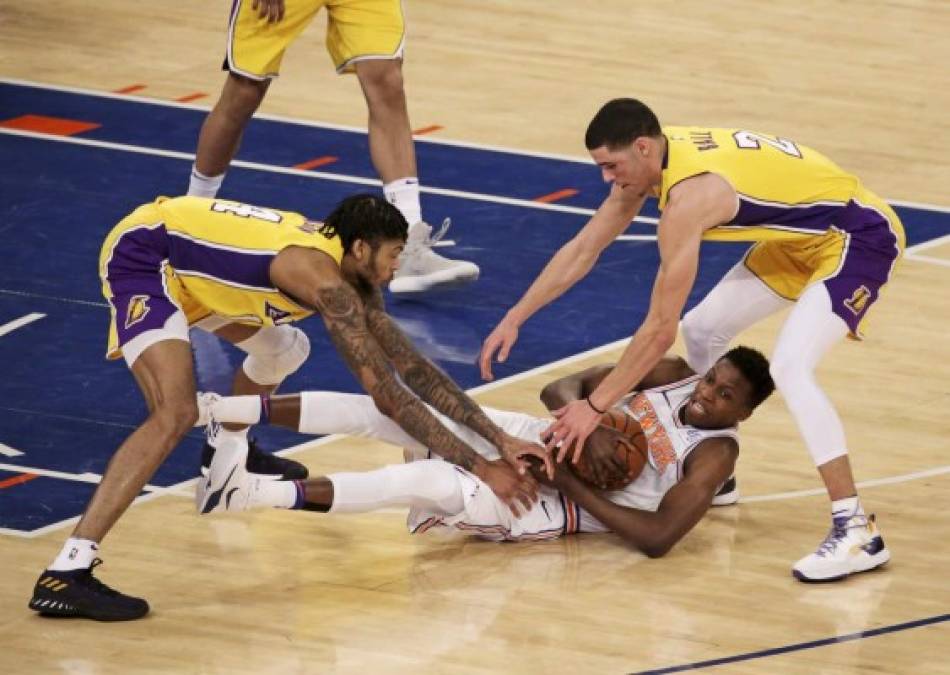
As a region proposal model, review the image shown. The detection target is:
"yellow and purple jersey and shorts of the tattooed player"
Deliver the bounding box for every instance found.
[99,197,343,359]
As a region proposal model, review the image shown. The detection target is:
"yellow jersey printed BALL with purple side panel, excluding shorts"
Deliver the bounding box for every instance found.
[659,127,903,246]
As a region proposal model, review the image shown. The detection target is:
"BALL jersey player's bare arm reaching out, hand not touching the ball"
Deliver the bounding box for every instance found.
[478,185,646,380]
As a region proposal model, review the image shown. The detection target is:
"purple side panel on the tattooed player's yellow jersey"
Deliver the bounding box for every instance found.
[168,232,276,291]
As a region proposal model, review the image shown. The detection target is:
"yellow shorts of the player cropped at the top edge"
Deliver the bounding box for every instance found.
[231,0,406,80]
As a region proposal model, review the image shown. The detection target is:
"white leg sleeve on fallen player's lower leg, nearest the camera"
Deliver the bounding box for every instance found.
[327,459,465,516]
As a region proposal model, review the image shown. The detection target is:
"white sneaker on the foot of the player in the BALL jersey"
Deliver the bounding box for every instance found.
[792,514,891,581]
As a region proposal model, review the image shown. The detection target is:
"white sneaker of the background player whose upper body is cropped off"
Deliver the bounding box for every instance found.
[389,218,479,293]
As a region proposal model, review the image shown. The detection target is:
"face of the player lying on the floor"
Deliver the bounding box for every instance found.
[686,359,752,429]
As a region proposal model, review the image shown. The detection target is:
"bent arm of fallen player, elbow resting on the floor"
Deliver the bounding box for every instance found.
[555,437,739,558]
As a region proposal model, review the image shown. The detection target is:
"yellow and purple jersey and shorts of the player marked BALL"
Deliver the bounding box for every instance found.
[659,127,905,337]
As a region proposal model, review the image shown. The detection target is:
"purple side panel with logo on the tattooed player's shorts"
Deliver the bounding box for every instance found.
[105,223,178,347]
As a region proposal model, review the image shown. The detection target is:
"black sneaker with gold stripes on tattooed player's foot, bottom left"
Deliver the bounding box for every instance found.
[29,558,148,621]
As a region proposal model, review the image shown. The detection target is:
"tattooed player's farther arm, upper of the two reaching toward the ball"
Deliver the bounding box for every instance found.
[366,291,553,473]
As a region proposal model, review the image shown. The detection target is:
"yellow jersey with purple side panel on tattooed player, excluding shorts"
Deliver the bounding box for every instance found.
[133,197,343,325]
